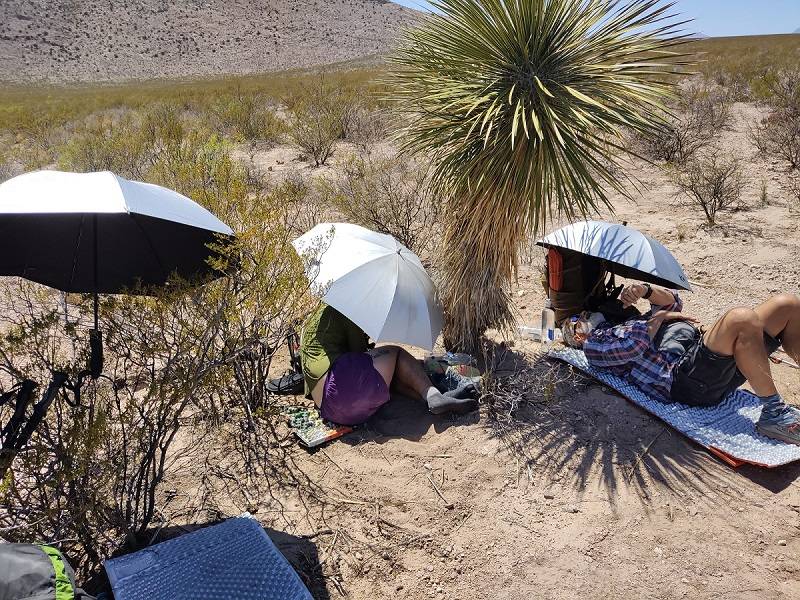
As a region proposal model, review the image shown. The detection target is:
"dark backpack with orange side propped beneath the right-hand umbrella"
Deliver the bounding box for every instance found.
[544,248,641,327]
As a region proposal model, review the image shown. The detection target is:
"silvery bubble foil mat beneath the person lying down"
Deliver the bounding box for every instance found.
[549,348,800,467]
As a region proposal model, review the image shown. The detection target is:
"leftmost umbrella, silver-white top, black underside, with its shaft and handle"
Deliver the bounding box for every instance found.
[0,171,233,376]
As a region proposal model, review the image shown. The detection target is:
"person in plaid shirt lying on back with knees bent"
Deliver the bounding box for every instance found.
[562,283,800,445]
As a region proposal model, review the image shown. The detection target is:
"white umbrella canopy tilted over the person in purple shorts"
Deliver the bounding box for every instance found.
[293,223,442,349]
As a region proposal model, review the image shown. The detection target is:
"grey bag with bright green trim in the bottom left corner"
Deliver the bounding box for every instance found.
[0,544,94,600]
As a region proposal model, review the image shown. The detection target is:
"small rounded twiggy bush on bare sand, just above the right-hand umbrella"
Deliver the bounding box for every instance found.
[674,151,743,226]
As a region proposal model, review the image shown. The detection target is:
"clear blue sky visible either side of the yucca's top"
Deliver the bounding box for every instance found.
[395,0,800,37]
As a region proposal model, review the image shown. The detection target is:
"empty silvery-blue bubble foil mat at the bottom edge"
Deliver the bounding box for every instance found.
[105,517,312,600]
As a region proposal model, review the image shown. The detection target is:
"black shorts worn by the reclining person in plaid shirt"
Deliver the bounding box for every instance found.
[671,331,781,406]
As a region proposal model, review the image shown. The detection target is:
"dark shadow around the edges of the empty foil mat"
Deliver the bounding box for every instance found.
[86,519,331,600]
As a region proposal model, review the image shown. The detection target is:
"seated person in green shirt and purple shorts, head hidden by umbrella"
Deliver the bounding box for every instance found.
[300,304,478,425]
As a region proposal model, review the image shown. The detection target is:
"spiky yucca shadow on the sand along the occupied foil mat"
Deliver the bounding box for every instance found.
[486,351,800,509]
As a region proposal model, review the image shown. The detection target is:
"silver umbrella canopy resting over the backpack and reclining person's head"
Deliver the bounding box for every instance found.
[537,221,692,291]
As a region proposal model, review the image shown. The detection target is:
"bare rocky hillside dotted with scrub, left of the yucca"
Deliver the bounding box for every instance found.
[0,0,416,83]
